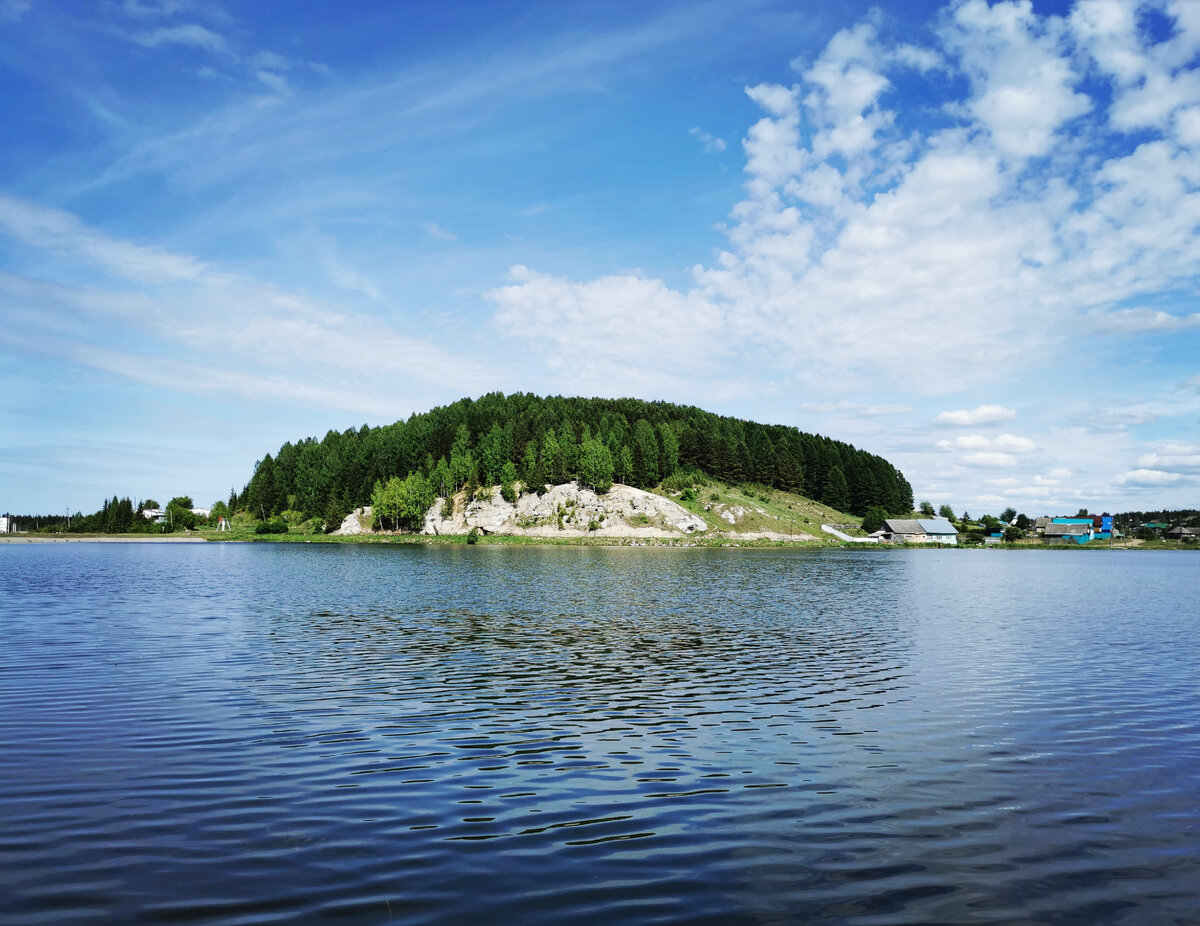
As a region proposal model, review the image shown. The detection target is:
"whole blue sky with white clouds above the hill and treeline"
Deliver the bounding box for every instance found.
[0,0,1200,516]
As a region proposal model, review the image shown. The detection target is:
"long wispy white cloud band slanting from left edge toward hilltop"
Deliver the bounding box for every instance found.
[0,197,492,414]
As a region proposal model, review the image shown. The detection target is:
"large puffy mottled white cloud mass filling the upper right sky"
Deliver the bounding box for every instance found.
[484,0,1200,398]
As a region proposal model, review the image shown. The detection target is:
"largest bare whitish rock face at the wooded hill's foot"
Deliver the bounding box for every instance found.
[421,482,708,537]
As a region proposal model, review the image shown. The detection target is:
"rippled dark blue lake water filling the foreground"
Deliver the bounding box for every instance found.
[0,543,1200,926]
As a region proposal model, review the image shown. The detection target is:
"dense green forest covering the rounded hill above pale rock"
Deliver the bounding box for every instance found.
[232,392,912,522]
